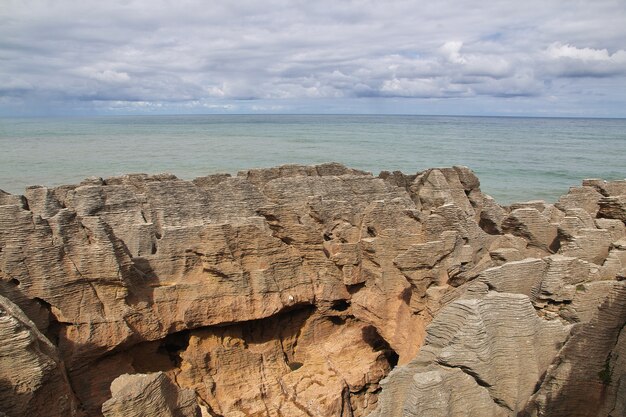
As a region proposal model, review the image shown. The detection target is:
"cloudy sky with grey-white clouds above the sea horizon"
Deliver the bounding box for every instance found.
[0,0,626,117]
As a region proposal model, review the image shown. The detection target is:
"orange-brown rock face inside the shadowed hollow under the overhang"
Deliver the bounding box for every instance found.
[176,307,391,416]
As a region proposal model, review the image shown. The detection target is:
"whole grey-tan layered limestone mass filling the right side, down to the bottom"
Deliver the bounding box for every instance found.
[370,176,626,417]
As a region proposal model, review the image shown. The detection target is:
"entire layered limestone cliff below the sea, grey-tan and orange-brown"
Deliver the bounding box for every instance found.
[0,163,626,417]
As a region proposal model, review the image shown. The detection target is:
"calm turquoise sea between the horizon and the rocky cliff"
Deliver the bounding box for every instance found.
[0,115,626,204]
